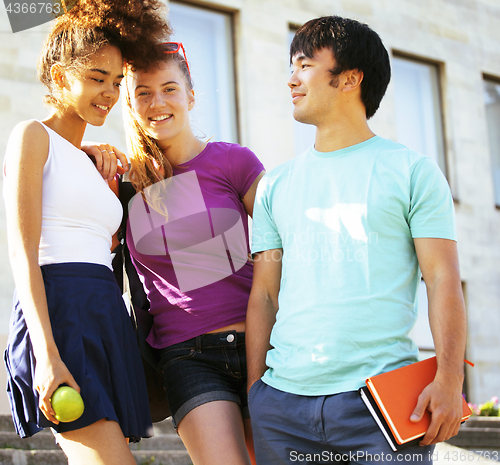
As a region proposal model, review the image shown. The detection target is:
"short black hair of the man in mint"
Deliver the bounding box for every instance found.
[290,16,391,119]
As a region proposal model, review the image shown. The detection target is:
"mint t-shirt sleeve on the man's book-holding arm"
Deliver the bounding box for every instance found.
[408,157,457,240]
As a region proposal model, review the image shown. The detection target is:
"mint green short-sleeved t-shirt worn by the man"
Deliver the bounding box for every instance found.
[252,136,456,395]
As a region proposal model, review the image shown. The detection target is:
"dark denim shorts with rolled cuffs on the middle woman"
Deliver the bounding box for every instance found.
[158,331,249,429]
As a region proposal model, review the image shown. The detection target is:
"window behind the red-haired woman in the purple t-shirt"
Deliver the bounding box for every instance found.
[169,1,238,143]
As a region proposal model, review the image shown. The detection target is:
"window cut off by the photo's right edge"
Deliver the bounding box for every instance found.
[484,78,500,207]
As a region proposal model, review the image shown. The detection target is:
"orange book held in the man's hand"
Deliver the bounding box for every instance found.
[360,357,471,451]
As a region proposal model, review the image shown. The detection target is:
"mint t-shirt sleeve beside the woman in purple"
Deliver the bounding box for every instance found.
[252,175,283,254]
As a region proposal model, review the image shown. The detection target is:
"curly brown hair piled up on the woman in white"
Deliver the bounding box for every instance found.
[37,0,171,106]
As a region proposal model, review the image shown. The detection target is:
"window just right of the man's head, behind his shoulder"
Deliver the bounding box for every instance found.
[392,56,446,174]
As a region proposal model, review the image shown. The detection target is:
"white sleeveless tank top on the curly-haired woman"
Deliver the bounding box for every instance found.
[38,123,122,269]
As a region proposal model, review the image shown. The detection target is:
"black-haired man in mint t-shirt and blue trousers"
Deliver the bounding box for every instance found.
[246,16,466,465]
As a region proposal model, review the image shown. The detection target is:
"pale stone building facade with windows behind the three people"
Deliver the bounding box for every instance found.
[0,0,500,411]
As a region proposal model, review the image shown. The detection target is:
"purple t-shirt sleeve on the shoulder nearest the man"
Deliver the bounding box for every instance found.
[228,145,264,197]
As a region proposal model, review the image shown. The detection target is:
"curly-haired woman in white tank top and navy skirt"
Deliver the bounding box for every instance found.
[3,0,170,465]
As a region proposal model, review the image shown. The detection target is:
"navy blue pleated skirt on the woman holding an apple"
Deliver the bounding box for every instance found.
[4,263,152,442]
